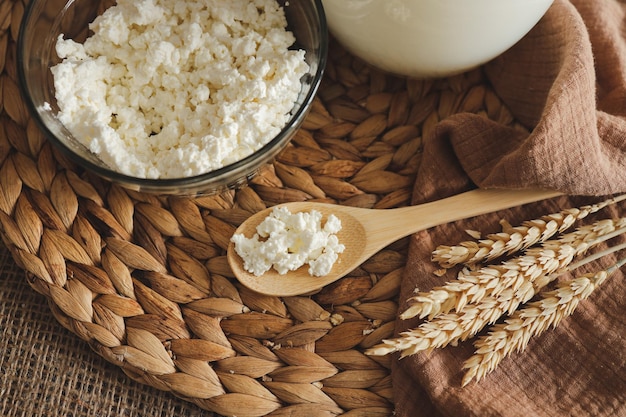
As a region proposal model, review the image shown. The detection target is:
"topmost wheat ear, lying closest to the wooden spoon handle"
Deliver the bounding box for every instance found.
[431,194,626,268]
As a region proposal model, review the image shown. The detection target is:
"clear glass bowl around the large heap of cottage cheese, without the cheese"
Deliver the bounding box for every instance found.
[17,0,328,195]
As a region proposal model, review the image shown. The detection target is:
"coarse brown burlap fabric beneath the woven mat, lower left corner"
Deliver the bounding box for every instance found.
[0,240,213,417]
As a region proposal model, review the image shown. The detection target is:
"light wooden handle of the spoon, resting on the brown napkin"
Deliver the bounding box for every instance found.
[354,189,562,253]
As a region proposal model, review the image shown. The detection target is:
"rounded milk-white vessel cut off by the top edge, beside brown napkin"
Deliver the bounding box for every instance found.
[322,0,553,78]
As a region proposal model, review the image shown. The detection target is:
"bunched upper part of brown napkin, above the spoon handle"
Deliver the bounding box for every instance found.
[416,0,626,198]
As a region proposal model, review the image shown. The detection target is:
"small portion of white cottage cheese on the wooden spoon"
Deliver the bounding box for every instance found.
[232,207,345,276]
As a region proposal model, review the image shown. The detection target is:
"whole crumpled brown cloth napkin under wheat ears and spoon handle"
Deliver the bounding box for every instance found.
[392,0,626,417]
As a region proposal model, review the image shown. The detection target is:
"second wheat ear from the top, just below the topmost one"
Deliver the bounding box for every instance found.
[400,218,626,320]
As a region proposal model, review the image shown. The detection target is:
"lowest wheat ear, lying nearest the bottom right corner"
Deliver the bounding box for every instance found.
[462,255,626,386]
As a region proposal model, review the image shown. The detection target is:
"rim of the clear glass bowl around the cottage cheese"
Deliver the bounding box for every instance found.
[17,0,329,195]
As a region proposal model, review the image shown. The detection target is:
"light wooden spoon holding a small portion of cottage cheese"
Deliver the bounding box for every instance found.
[228,189,561,296]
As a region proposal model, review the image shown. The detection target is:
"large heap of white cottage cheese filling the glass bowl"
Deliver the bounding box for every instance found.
[52,0,308,178]
